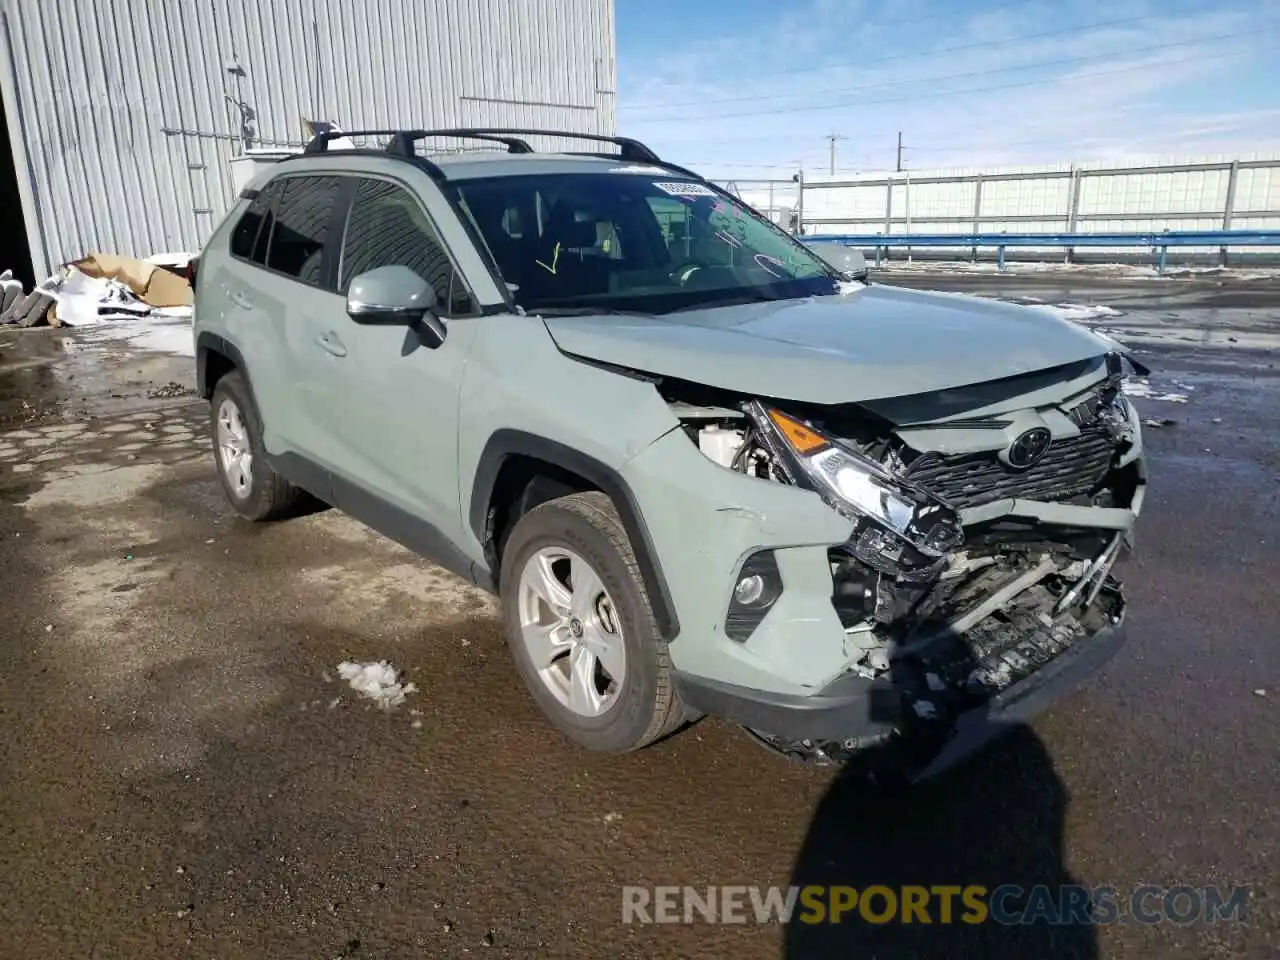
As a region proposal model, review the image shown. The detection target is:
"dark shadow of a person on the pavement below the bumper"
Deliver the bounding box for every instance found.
[782,726,1098,960]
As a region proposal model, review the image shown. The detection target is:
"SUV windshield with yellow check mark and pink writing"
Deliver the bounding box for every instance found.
[452,173,838,314]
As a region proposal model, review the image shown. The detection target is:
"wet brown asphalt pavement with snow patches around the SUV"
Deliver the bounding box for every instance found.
[0,273,1280,960]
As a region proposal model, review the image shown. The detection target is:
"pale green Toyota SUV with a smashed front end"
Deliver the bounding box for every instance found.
[195,129,1146,780]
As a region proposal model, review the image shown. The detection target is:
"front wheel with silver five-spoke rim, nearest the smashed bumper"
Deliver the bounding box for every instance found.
[500,492,685,754]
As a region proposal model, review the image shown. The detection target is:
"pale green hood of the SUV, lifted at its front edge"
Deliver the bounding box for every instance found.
[544,284,1115,403]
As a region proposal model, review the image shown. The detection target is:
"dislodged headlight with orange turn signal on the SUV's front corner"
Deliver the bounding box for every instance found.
[753,403,964,557]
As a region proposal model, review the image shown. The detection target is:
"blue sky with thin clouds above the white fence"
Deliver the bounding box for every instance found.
[616,0,1280,179]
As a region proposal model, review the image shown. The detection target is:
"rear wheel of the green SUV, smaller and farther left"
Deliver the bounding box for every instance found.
[209,370,305,522]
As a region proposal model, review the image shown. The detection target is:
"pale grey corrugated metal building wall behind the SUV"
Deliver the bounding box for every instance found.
[0,0,617,275]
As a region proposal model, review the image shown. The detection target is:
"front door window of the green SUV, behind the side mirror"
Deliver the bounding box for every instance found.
[338,179,476,316]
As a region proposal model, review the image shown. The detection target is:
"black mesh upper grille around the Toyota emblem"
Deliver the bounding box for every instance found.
[906,424,1116,508]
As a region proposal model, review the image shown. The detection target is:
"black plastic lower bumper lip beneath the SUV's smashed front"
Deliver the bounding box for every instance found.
[675,617,1125,781]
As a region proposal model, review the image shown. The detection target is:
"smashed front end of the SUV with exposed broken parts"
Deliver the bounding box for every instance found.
[659,356,1146,767]
